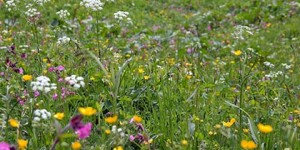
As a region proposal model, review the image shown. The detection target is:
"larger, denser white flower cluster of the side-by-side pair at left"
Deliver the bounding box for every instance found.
[31,76,57,93]
